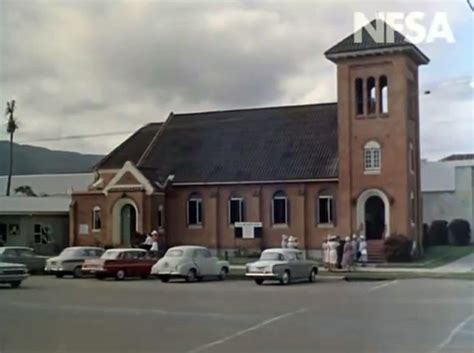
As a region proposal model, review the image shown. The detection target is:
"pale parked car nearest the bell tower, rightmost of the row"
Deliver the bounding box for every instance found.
[245,249,318,284]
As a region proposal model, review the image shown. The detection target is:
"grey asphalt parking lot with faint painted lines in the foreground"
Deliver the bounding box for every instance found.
[0,276,474,353]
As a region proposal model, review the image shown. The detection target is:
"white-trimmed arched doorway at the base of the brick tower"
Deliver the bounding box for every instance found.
[356,189,390,240]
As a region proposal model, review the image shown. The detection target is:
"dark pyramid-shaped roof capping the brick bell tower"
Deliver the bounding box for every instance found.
[324,19,429,64]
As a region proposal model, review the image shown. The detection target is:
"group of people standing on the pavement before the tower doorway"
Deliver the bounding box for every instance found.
[322,234,368,271]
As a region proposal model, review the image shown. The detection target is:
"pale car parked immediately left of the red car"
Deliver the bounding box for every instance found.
[44,246,104,278]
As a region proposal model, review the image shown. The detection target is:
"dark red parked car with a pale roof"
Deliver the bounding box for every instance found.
[82,248,156,280]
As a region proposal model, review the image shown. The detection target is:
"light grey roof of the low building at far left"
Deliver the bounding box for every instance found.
[0,196,71,214]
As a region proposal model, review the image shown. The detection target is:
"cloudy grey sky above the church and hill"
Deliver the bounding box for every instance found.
[0,0,474,160]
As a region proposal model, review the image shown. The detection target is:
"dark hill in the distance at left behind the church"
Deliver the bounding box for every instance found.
[0,141,103,175]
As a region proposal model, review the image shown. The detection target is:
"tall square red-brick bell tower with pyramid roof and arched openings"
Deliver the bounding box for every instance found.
[325,20,429,250]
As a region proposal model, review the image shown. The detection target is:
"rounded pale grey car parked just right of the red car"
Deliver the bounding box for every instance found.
[151,246,230,282]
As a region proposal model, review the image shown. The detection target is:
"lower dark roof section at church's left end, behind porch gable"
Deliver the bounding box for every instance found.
[94,123,163,170]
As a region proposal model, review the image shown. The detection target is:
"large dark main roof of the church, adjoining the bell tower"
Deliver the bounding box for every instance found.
[137,103,338,184]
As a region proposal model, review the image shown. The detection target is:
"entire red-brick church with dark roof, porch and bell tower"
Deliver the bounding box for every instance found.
[70,21,429,260]
